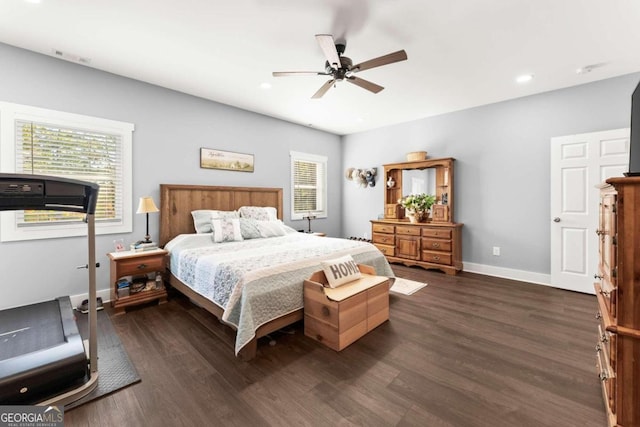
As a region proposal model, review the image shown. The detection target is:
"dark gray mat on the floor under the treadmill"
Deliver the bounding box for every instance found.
[64,310,140,411]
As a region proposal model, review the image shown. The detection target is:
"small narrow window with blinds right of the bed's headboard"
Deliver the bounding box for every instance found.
[290,151,327,219]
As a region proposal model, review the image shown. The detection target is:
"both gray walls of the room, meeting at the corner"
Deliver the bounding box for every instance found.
[0,38,640,308]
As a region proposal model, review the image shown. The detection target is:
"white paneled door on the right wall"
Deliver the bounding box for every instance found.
[550,128,629,294]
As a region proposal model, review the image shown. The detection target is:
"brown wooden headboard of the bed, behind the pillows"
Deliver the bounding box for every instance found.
[160,184,282,246]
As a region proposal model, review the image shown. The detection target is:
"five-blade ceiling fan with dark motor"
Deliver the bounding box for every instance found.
[273,34,407,99]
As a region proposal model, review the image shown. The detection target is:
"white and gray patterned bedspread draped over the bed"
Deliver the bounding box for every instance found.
[165,233,393,355]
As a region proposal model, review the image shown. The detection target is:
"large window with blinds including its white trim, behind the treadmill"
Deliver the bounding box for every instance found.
[0,102,133,241]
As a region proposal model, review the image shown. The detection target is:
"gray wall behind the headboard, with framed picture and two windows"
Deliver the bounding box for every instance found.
[0,44,342,308]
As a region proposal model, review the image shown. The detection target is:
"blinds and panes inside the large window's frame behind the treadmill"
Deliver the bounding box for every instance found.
[15,120,123,227]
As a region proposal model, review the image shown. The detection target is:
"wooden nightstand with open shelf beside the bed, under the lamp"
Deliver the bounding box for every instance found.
[107,249,168,314]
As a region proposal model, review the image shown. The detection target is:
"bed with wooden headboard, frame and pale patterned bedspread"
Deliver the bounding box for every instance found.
[160,184,393,360]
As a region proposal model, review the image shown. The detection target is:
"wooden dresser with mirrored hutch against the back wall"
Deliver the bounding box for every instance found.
[371,157,462,274]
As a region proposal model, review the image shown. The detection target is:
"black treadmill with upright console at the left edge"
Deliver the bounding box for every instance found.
[0,173,99,405]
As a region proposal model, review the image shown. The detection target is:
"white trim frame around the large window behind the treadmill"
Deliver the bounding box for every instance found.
[0,102,134,242]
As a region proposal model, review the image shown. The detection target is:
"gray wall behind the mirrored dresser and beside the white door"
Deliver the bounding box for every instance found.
[343,74,640,274]
